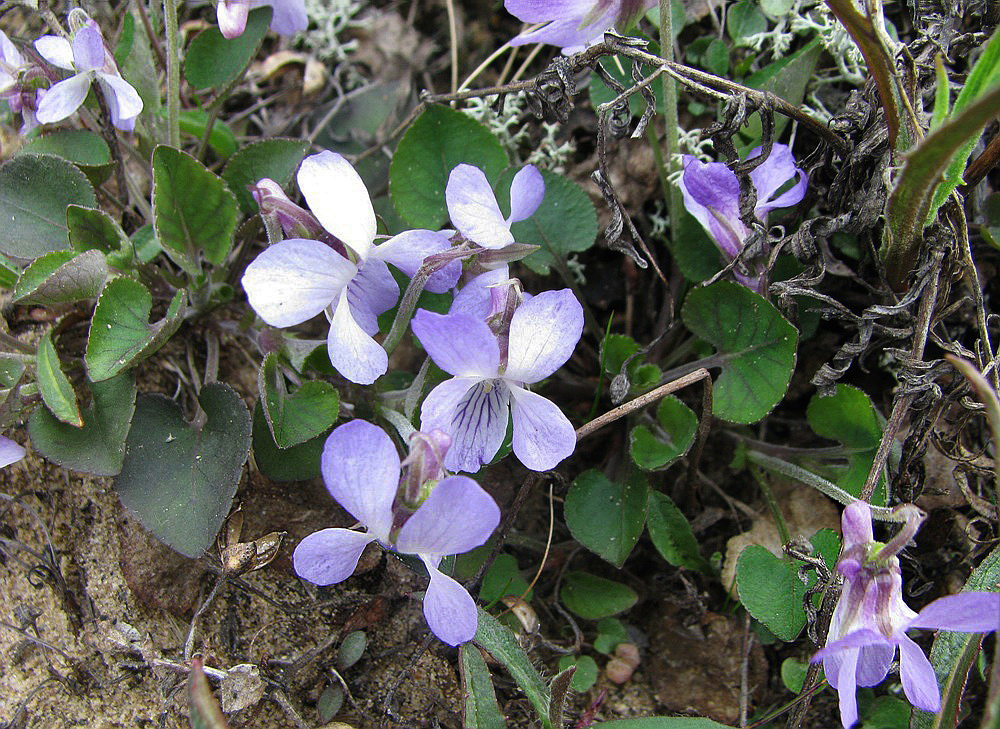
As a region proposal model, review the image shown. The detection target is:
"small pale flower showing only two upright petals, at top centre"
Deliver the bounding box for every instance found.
[444,164,545,249]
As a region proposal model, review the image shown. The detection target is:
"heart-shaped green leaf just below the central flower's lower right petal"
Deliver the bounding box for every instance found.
[564,469,649,567]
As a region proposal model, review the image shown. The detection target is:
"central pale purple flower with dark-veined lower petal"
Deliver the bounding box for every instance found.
[410,289,583,472]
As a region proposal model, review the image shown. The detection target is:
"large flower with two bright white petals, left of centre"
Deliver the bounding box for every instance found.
[243,152,462,385]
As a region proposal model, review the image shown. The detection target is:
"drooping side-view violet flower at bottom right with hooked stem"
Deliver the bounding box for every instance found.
[812,501,1000,729]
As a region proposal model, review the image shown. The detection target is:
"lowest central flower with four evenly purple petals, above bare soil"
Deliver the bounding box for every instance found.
[293,420,500,645]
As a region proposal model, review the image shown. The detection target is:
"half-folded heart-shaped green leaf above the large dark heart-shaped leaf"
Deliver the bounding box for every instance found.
[84,278,187,382]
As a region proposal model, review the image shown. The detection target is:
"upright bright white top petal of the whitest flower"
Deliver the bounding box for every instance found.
[296,151,377,259]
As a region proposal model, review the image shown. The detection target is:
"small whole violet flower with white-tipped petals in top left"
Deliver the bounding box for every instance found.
[35,8,142,132]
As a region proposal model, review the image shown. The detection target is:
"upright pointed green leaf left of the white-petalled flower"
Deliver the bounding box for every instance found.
[153,144,236,276]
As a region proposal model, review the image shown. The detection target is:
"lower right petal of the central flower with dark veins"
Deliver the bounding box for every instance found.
[510,385,576,471]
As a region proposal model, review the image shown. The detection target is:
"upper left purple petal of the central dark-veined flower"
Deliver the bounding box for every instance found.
[410,309,500,376]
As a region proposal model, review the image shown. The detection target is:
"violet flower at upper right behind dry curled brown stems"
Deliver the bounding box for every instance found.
[680,144,808,292]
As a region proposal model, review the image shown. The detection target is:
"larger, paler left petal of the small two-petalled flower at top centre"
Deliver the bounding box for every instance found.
[444,164,514,248]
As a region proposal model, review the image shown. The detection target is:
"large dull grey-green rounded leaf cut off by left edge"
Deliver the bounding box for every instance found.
[0,154,97,259]
